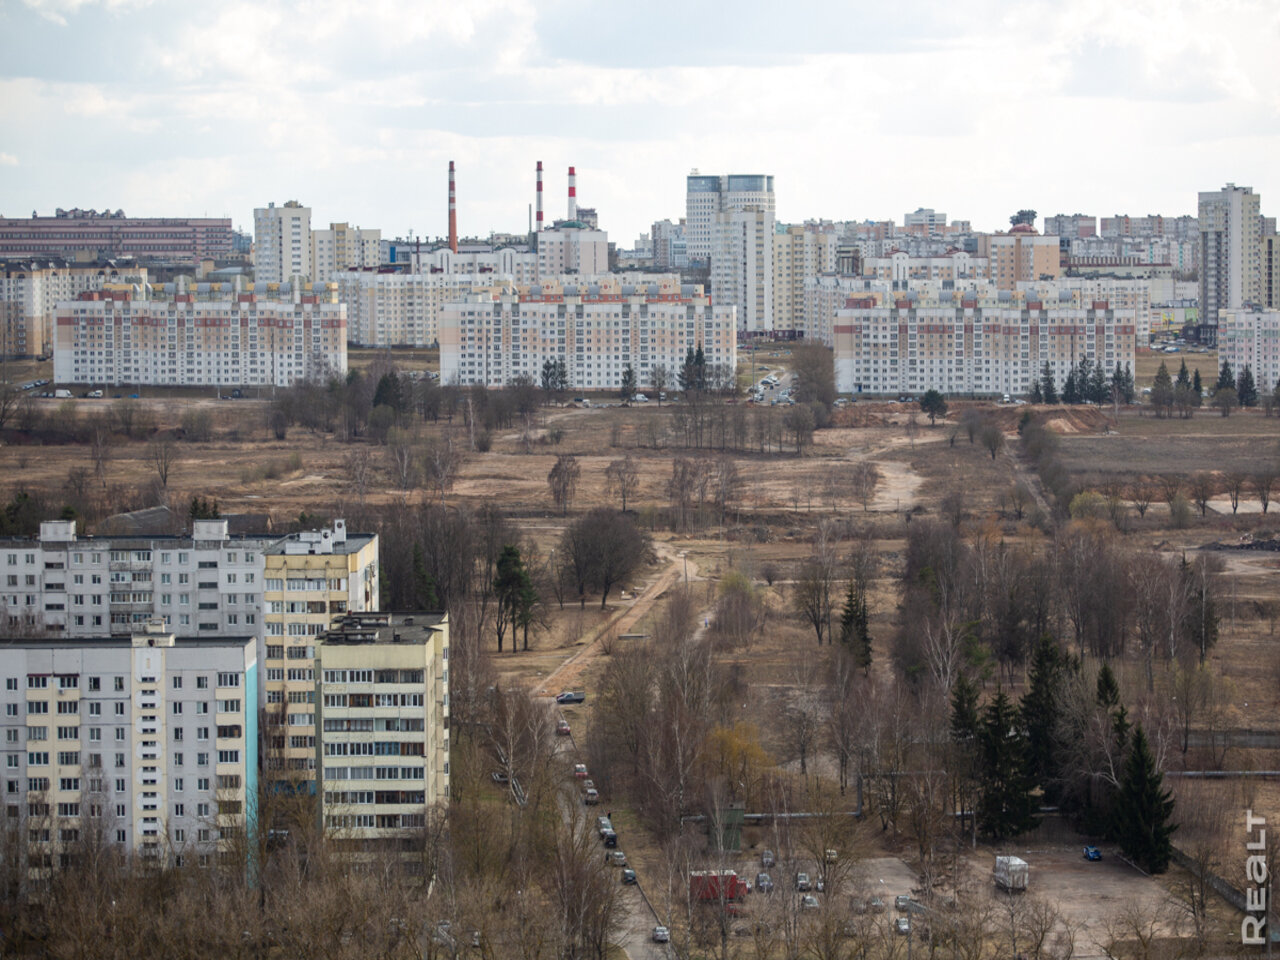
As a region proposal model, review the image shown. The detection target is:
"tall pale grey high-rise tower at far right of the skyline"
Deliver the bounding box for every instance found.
[1199,183,1262,335]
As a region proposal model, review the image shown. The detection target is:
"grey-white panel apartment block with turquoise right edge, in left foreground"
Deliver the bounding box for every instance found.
[0,620,257,881]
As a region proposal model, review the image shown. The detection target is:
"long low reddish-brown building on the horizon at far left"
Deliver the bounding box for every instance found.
[0,210,232,264]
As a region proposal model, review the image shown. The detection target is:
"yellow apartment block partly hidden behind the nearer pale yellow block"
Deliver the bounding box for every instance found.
[262,520,379,783]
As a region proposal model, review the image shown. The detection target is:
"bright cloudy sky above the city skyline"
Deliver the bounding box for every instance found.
[0,0,1280,247]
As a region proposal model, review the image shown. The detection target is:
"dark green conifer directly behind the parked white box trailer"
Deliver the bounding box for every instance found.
[978,690,1037,841]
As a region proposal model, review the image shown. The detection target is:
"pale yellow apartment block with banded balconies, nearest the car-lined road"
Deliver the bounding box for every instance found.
[315,613,449,873]
